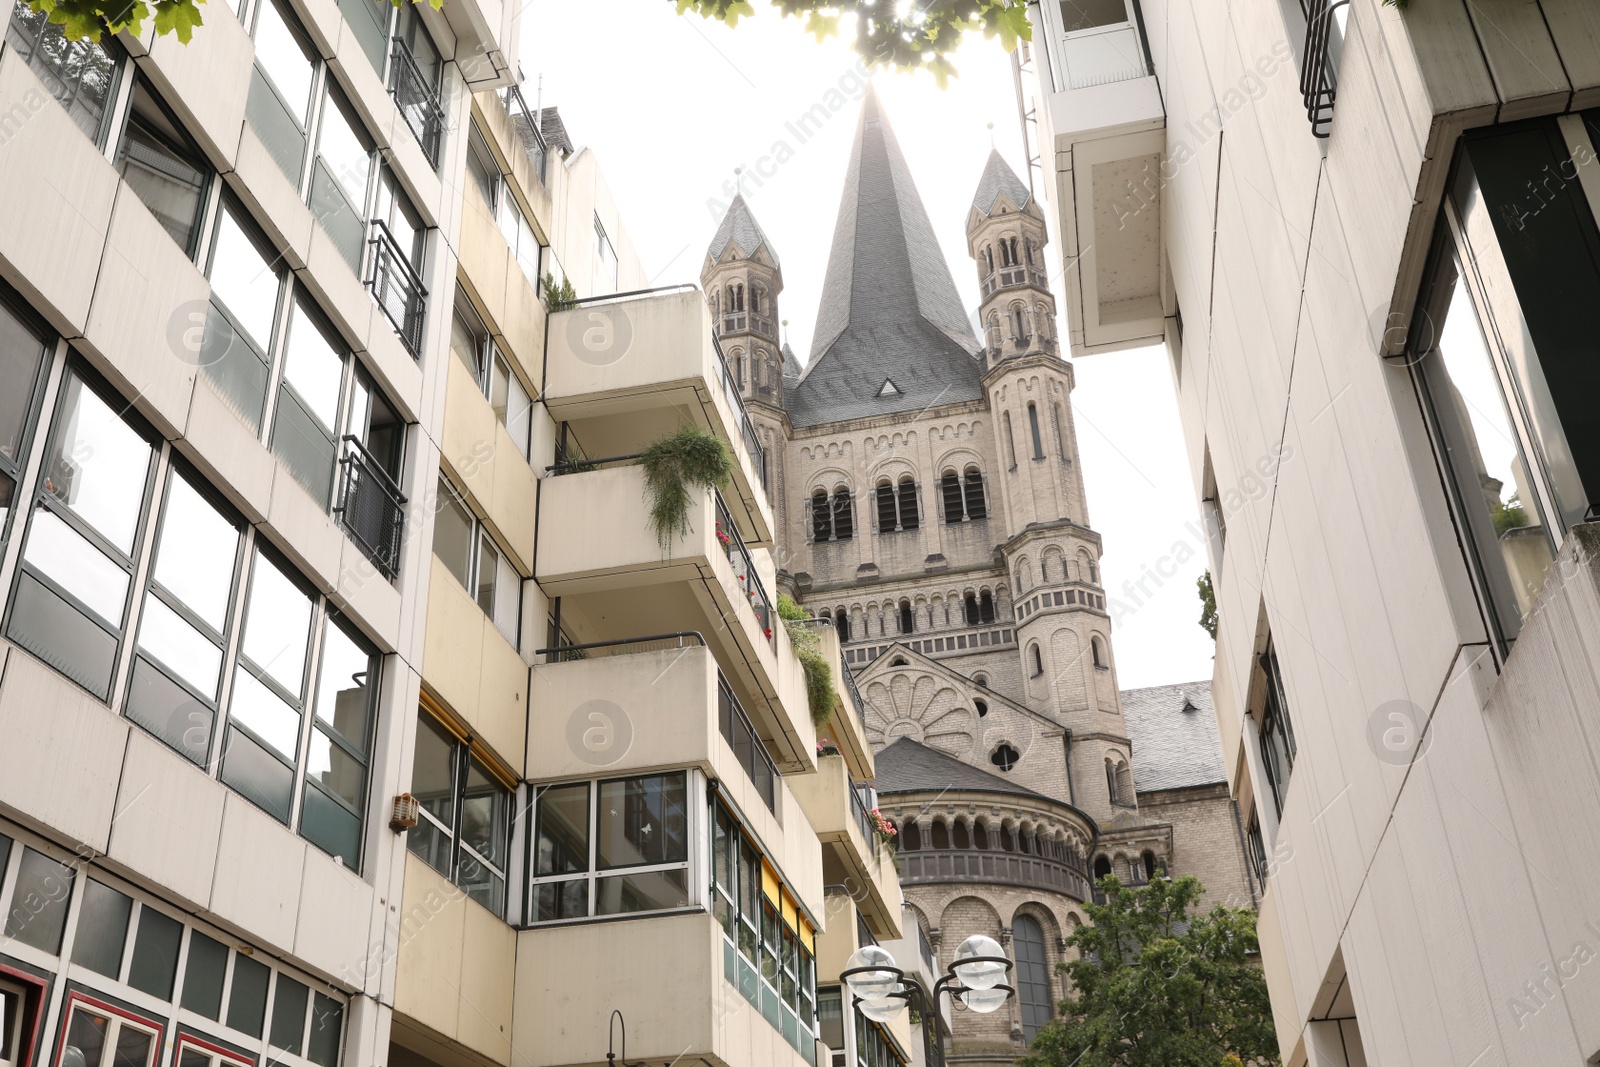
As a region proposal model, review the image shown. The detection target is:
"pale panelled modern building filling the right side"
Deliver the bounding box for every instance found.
[1019,0,1600,1067]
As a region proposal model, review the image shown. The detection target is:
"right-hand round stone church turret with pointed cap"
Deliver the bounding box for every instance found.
[966,152,1134,819]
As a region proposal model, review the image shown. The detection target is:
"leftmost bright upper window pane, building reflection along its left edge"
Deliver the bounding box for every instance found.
[45,376,150,555]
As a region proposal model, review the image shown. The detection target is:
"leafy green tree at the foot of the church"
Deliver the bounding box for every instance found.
[1019,875,1278,1067]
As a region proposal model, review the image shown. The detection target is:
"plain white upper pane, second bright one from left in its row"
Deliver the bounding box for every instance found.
[155,474,238,633]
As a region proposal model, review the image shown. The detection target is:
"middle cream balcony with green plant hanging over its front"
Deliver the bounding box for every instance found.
[536,466,816,773]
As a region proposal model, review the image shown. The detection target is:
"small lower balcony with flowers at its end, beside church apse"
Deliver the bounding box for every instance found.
[789,755,901,941]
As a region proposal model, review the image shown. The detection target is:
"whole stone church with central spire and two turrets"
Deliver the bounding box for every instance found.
[701,91,1254,1064]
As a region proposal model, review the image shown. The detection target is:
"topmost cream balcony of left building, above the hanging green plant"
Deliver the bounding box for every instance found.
[544,286,773,547]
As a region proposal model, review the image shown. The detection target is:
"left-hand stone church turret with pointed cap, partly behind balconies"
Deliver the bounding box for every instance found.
[701,195,794,525]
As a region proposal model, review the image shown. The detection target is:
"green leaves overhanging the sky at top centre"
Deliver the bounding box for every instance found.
[672,0,1034,82]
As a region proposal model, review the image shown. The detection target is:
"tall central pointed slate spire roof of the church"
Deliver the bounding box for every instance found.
[787,88,984,426]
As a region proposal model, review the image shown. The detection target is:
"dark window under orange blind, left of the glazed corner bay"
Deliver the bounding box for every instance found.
[406,712,510,915]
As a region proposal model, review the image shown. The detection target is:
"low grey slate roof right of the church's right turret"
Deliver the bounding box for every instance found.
[1122,681,1227,793]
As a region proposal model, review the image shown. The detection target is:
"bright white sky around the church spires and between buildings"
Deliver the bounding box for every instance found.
[522,0,1213,689]
